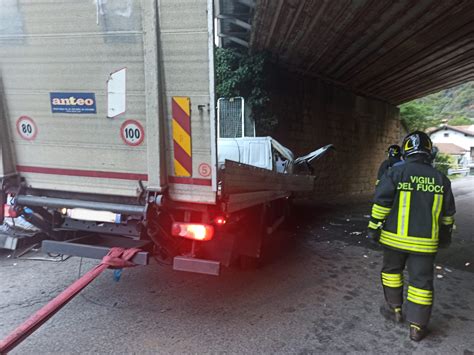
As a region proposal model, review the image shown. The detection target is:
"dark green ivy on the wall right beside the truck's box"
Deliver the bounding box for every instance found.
[216,48,277,134]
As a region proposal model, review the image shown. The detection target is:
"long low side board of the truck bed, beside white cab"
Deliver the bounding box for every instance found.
[221,160,314,195]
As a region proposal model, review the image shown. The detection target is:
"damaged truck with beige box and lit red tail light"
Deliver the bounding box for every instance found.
[0,0,330,275]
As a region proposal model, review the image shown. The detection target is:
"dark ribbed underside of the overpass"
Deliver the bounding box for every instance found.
[250,0,474,105]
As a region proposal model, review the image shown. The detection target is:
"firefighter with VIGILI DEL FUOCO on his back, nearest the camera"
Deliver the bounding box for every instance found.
[368,131,456,341]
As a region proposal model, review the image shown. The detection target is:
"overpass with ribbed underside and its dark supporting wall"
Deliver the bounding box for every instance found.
[218,0,474,198]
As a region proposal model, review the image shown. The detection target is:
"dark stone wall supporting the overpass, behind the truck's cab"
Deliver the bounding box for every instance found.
[261,69,405,200]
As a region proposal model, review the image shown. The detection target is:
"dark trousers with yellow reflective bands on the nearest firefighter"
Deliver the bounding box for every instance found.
[381,248,435,326]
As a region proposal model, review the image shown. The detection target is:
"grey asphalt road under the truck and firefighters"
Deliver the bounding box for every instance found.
[0,178,474,355]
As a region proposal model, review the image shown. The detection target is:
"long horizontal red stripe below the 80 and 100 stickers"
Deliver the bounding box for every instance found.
[16,165,148,181]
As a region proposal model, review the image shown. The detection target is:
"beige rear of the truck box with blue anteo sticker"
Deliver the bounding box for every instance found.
[0,0,216,203]
